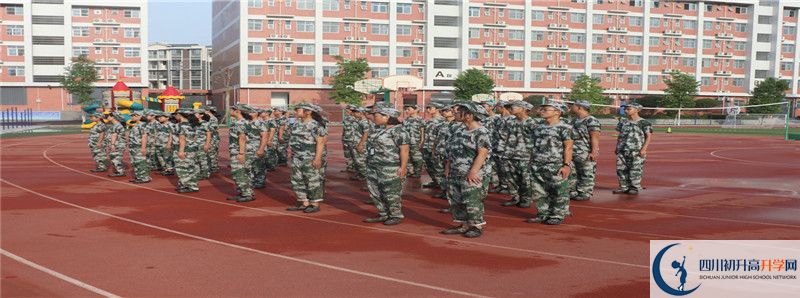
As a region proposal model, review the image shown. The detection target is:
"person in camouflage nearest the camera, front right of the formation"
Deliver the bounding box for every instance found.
[442,102,492,238]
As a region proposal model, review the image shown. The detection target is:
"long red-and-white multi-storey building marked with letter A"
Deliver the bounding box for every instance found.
[213,0,800,114]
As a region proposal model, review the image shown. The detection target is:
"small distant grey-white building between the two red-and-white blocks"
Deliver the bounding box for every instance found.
[147,43,211,93]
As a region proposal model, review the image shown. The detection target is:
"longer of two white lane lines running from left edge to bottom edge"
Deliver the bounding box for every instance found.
[0,179,487,297]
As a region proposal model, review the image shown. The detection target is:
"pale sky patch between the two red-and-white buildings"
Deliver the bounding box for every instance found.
[147,0,211,45]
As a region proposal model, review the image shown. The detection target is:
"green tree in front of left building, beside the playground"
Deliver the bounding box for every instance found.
[61,55,98,105]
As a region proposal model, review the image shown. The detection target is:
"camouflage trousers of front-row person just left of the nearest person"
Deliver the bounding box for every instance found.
[366,164,406,218]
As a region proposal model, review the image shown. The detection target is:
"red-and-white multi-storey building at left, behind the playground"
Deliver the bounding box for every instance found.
[0,0,147,115]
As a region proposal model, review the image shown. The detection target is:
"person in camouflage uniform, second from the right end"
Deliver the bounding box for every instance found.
[569,100,600,201]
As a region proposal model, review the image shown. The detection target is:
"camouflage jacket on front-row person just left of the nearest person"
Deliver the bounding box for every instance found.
[366,125,411,167]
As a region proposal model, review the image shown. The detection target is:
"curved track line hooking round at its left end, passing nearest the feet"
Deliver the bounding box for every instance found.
[39,142,650,269]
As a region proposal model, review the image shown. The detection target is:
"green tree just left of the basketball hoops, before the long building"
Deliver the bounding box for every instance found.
[330,56,370,105]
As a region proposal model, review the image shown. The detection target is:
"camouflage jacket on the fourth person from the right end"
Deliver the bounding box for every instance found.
[502,116,539,161]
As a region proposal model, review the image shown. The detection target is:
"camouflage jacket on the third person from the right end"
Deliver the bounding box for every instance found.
[533,123,573,164]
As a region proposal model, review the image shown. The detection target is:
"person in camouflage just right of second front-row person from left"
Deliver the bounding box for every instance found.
[250,109,269,189]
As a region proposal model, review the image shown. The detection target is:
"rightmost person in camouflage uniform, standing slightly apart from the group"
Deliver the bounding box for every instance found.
[613,103,653,195]
